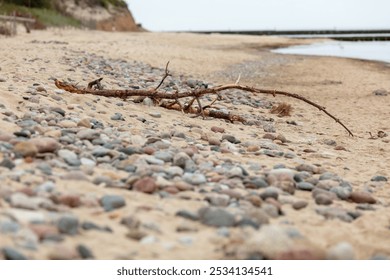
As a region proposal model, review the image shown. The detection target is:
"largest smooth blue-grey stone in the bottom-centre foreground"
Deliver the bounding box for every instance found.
[198,207,235,227]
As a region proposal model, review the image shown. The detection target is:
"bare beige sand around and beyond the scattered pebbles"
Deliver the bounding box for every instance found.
[0,29,390,259]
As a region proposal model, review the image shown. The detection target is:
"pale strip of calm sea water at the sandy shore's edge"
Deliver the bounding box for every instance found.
[273,41,390,63]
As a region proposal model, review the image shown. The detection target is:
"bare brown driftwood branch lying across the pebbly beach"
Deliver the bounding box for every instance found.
[55,67,353,136]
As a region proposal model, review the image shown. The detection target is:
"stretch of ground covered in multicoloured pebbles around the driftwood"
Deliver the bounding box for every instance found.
[0,31,390,259]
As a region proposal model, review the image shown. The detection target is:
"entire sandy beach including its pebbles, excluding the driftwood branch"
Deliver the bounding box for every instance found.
[0,29,390,259]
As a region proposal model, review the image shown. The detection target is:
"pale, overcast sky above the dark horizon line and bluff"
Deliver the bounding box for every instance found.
[126,0,390,31]
